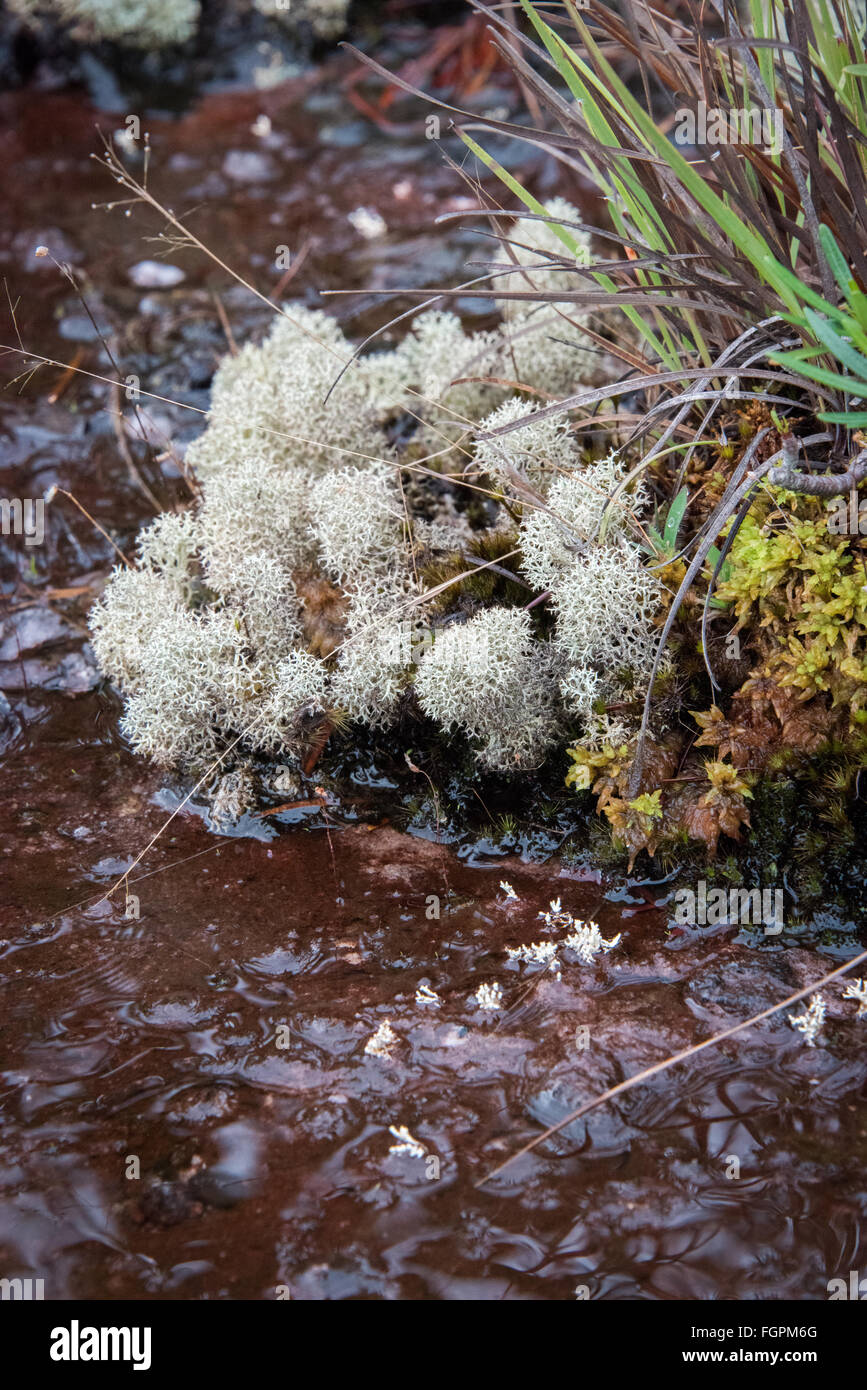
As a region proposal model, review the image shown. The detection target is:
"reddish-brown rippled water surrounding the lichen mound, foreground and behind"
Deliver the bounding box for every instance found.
[0,48,867,1300]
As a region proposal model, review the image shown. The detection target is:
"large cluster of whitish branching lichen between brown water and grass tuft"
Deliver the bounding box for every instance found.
[90,204,661,795]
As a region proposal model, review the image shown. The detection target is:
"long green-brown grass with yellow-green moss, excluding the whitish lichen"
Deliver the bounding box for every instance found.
[408,0,867,858]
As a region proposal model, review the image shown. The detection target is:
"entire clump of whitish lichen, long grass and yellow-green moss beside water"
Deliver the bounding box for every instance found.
[86,0,867,889]
